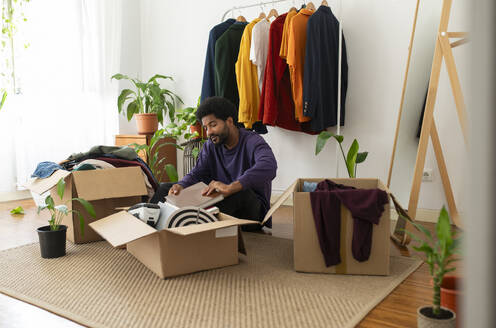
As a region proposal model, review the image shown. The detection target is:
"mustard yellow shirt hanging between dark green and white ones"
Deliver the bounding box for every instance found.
[235,18,260,129]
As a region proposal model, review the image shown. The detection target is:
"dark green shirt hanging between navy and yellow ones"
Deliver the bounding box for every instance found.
[215,22,248,116]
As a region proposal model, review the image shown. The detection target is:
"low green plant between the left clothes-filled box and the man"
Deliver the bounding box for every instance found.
[130,129,181,182]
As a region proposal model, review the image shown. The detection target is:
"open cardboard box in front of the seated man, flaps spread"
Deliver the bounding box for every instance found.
[90,211,255,279]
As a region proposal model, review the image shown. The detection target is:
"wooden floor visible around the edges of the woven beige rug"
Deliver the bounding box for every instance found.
[0,200,462,328]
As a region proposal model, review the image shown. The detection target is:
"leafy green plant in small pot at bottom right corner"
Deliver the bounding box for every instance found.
[400,206,460,328]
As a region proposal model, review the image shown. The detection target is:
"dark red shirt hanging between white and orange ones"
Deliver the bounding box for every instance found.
[258,14,316,134]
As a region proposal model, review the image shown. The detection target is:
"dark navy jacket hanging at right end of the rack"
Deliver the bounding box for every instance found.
[303,6,348,131]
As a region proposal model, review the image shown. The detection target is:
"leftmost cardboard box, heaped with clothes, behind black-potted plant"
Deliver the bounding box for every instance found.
[26,166,147,244]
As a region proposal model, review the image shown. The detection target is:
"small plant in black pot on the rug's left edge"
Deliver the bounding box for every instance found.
[37,178,96,258]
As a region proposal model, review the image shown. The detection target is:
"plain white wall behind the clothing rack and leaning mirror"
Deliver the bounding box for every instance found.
[134,0,463,213]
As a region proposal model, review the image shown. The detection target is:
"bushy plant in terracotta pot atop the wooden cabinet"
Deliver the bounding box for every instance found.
[112,74,182,134]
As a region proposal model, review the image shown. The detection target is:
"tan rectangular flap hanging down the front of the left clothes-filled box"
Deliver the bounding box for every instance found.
[72,166,147,201]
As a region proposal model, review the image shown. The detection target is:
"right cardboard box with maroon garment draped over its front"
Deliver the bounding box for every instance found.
[264,178,390,275]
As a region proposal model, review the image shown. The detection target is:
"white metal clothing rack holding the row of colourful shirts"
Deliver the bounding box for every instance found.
[221,0,343,178]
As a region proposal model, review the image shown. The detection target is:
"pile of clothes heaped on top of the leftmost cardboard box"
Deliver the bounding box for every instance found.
[31,146,159,198]
